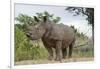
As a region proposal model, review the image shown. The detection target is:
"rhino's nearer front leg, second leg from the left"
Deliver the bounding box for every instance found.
[56,41,62,62]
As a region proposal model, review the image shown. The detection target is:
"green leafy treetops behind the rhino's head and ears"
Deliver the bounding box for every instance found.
[15,11,60,29]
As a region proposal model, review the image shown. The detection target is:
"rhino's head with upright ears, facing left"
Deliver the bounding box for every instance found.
[26,16,46,40]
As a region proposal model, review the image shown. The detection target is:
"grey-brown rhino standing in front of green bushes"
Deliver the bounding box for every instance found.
[26,16,75,61]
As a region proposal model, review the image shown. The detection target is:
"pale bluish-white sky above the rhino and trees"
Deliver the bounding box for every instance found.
[15,4,92,37]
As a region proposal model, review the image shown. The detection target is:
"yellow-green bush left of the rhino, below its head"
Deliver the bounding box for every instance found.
[14,26,48,61]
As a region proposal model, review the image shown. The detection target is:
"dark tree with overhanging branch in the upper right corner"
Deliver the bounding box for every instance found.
[65,7,94,40]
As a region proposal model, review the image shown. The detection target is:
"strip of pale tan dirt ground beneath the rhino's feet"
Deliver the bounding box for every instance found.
[15,57,94,65]
